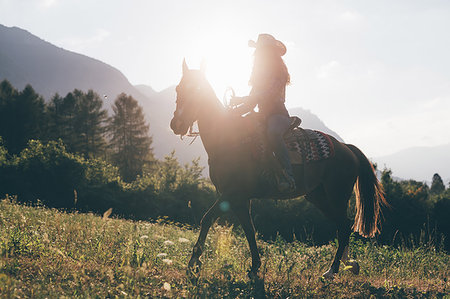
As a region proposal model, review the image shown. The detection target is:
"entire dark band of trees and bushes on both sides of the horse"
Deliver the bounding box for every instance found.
[0,81,450,250]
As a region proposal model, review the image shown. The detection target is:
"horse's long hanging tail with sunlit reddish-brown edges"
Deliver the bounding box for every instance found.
[347,144,388,238]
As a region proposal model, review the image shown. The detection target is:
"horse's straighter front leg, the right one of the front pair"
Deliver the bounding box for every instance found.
[232,200,261,279]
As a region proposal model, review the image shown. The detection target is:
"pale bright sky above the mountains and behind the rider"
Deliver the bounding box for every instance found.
[0,0,450,157]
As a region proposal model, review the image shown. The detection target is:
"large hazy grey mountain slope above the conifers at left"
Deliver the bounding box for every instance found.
[0,25,142,99]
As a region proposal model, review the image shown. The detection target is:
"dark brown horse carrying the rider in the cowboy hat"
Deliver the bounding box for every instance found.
[170,61,385,278]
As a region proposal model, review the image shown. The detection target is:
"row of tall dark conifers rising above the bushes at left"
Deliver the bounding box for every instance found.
[0,80,154,182]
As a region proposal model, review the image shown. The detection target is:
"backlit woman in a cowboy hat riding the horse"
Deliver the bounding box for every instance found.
[230,34,295,193]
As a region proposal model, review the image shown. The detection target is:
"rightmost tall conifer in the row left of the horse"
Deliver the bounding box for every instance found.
[109,93,153,182]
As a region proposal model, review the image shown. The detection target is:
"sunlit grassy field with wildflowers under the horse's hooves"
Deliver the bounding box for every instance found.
[0,200,450,298]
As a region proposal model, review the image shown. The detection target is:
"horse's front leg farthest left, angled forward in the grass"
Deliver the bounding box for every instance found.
[188,200,220,273]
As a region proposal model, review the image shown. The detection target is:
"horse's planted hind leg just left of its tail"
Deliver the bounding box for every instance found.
[307,186,352,278]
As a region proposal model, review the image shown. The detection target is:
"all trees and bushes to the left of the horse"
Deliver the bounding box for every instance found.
[0,80,216,224]
